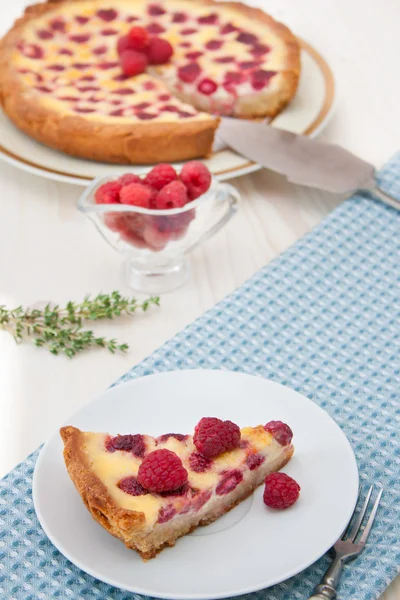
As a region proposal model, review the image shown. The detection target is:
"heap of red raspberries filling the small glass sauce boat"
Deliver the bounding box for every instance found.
[95,161,211,252]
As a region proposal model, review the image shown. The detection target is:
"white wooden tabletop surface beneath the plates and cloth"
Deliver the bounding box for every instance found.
[0,0,400,600]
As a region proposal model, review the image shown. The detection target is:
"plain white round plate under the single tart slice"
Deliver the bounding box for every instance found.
[33,370,358,600]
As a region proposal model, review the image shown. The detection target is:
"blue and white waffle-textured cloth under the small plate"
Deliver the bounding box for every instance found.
[0,153,400,600]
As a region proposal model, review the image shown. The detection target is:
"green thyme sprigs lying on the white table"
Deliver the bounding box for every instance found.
[0,291,160,358]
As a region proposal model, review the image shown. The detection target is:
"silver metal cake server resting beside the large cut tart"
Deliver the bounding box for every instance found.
[218,117,400,210]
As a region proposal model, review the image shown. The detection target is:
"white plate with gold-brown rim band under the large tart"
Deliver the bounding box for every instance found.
[0,40,334,186]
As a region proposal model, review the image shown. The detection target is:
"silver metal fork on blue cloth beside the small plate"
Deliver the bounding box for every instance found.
[309,485,383,600]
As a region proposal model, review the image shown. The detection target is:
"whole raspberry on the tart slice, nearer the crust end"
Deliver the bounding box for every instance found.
[138,448,188,492]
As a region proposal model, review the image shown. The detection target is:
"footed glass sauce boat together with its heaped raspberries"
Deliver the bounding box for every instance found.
[78,161,240,293]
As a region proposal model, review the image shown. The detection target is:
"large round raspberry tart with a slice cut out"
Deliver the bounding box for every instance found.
[0,0,300,164]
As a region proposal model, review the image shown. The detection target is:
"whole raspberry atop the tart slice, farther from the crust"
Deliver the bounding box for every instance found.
[193,417,240,458]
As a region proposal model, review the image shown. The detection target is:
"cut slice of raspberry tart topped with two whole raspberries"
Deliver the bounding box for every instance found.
[60,417,293,559]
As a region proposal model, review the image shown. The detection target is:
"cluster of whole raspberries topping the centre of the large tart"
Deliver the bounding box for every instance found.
[117,27,173,77]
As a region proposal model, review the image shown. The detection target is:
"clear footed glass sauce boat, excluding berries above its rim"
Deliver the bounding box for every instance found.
[78,176,240,294]
